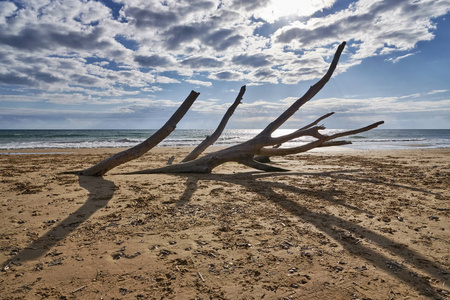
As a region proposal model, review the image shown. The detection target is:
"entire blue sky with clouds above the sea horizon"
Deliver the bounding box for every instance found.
[0,0,450,129]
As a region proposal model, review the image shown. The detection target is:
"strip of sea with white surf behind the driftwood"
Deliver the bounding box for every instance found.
[0,129,450,150]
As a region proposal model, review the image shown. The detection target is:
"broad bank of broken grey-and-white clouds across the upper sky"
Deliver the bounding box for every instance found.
[0,0,449,115]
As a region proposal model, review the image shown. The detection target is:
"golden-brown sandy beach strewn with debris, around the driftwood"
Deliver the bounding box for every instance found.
[0,148,450,299]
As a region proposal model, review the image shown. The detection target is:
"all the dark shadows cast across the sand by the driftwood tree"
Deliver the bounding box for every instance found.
[3,171,450,299]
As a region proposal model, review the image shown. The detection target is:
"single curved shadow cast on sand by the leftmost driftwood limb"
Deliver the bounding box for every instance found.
[2,176,116,266]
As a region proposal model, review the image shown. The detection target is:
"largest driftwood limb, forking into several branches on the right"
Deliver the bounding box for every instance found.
[126,42,384,174]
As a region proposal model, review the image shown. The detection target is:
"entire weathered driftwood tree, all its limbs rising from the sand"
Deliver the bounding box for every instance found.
[73,42,384,176]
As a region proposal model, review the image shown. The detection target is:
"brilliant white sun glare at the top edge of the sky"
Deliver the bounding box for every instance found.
[260,0,335,22]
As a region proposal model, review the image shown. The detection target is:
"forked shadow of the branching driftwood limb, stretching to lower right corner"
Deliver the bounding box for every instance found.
[177,172,450,299]
